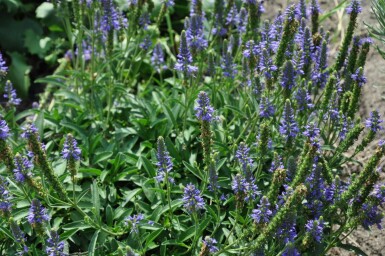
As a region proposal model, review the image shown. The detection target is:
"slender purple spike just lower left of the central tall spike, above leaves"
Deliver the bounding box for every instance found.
[156,137,173,183]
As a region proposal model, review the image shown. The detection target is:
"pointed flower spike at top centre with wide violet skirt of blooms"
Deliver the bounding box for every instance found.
[175,30,198,77]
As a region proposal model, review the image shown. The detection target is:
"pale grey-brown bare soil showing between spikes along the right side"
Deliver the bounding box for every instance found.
[265,0,385,256]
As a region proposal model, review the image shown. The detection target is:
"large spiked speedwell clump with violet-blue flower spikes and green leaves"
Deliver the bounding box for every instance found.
[0,0,385,256]
